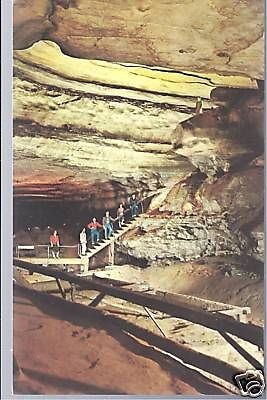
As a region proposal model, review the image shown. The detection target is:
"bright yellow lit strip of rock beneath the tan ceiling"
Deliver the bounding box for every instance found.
[14,41,257,99]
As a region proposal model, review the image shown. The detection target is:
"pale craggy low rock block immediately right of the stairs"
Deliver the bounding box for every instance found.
[120,215,248,264]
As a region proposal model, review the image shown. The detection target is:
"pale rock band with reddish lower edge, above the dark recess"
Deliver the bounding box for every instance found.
[14,127,192,209]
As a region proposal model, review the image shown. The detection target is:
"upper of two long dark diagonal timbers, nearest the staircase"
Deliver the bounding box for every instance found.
[13,259,263,348]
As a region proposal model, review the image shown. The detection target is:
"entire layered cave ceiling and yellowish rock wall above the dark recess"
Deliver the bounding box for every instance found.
[13,0,264,216]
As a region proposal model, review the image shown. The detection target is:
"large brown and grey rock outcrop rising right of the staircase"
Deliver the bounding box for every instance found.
[142,159,264,263]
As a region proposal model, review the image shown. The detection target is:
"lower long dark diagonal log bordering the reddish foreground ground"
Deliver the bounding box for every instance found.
[14,284,243,384]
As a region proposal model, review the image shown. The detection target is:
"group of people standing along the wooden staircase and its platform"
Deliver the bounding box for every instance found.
[49,194,139,258]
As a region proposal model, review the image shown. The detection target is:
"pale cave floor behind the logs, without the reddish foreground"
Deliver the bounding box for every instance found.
[76,263,264,370]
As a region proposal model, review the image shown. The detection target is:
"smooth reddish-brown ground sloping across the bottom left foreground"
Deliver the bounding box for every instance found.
[14,284,228,396]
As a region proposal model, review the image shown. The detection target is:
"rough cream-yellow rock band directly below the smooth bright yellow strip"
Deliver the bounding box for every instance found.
[14,78,193,144]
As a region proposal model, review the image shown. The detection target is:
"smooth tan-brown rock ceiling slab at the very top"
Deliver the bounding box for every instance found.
[14,0,264,79]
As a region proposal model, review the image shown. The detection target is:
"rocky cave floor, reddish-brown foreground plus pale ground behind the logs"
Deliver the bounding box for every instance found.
[14,258,264,395]
